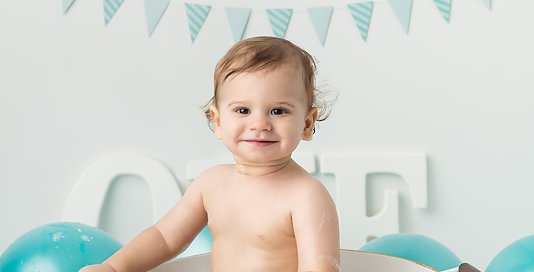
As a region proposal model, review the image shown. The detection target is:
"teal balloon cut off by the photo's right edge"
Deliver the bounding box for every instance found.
[486,235,534,272]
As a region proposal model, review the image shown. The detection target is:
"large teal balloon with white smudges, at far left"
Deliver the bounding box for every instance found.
[0,222,122,272]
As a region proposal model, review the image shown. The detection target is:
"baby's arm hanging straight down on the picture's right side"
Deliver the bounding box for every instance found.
[292,179,340,272]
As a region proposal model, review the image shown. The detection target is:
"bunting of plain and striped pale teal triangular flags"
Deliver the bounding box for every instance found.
[61,0,491,47]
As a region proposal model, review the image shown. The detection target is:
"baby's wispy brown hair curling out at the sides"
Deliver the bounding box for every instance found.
[203,36,337,130]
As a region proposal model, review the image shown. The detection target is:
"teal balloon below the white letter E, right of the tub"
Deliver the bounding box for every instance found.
[360,233,462,271]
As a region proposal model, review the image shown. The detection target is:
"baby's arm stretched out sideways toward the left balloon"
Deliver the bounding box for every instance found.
[80,174,208,272]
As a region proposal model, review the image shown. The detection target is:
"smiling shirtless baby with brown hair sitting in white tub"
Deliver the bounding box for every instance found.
[80,37,339,272]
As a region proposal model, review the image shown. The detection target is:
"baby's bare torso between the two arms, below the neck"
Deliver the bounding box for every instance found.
[202,165,304,272]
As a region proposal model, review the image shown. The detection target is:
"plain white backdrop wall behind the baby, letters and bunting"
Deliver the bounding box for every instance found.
[0,0,534,269]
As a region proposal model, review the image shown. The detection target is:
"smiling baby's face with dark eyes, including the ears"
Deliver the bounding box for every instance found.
[211,65,317,163]
